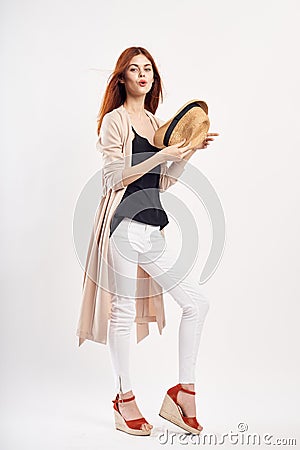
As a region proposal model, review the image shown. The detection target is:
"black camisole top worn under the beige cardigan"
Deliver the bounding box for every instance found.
[109,127,169,237]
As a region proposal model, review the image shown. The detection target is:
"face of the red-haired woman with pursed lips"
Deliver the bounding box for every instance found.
[120,54,154,96]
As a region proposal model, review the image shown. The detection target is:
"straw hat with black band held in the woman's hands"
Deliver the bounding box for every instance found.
[153,99,210,148]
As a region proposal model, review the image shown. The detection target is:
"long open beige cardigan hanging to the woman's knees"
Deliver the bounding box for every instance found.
[76,105,186,346]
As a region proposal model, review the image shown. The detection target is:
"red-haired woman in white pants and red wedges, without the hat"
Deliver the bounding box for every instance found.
[78,47,217,435]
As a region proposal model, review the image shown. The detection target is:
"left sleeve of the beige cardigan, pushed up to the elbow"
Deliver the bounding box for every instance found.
[96,113,125,194]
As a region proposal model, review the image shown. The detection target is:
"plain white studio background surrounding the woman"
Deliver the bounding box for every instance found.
[0,0,300,450]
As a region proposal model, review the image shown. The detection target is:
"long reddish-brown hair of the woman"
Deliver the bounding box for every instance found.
[97,47,163,136]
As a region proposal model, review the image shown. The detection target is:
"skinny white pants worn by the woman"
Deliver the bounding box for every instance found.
[108,218,209,392]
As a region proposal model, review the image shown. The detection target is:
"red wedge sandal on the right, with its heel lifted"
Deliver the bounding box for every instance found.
[159,383,203,434]
